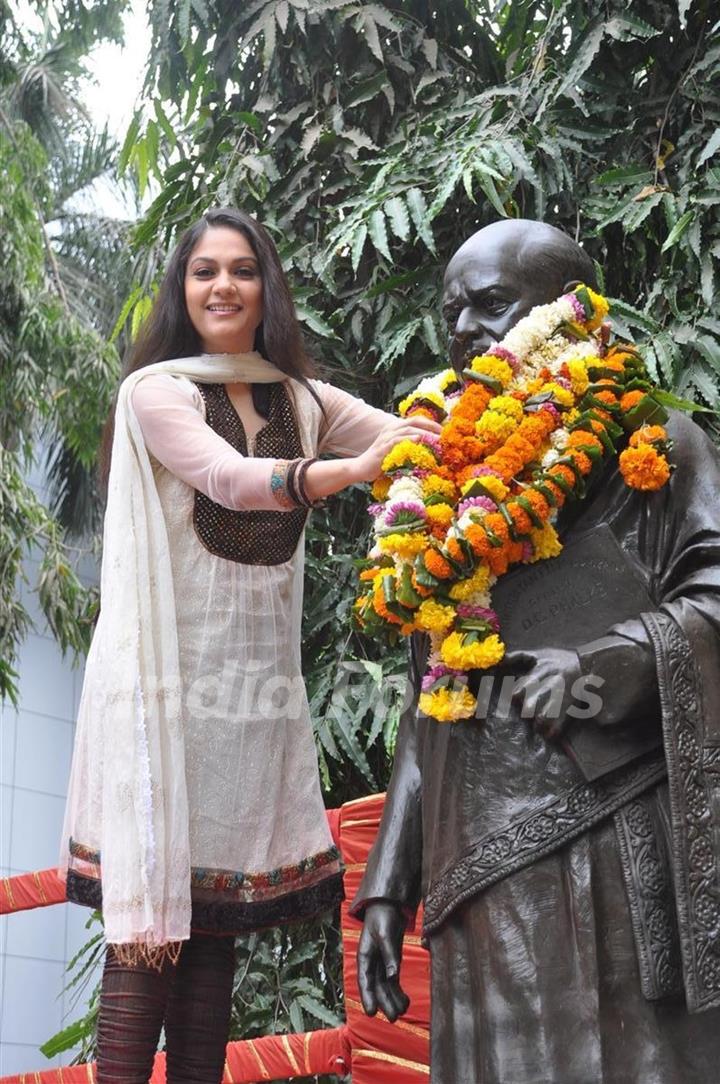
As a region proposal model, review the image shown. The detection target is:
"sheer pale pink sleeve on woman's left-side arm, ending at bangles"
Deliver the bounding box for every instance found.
[132,373,297,512]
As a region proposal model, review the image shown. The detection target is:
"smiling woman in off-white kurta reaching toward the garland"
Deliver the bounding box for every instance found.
[62,209,437,1084]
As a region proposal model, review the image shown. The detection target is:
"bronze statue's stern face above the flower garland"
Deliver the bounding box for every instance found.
[442,229,563,373]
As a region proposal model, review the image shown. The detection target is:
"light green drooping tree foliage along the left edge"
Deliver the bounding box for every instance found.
[0,5,125,700]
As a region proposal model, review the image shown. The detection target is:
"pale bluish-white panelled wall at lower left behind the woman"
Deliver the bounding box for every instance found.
[0,459,98,1075]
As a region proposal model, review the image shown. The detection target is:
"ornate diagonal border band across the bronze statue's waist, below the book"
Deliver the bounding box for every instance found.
[423,753,666,937]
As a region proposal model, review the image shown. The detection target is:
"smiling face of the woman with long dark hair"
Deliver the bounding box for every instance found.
[185,225,262,353]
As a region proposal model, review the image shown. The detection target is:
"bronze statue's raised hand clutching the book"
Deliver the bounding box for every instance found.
[502,647,582,741]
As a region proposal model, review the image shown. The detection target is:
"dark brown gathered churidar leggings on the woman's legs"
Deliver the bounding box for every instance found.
[97,933,235,1084]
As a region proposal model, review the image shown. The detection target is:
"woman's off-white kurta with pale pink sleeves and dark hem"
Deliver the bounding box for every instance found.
[63,373,391,932]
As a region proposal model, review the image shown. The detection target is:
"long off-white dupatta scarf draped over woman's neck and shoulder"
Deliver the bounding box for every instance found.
[61,352,287,966]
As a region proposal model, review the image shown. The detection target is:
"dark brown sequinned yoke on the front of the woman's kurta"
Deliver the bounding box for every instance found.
[193,383,308,565]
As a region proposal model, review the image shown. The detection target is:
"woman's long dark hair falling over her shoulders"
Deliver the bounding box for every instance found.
[100,207,317,488]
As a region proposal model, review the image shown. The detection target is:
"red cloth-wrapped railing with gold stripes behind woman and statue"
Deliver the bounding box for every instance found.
[0,795,429,1084]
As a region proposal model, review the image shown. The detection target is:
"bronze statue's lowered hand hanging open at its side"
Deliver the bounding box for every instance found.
[358,900,410,1022]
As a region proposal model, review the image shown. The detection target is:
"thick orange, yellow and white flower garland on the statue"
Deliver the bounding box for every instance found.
[355,286,671,722]
